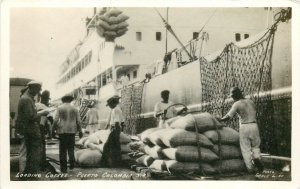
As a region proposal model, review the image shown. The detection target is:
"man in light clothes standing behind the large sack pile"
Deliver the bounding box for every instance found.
[154,90,177,128]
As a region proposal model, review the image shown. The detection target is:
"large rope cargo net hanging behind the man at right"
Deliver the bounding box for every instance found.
[199,28,275,154]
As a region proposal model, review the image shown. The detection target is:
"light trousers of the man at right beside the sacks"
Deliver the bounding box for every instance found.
[240,123,260,170]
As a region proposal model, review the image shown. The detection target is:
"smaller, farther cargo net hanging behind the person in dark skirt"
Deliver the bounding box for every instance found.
[121,83,144,135]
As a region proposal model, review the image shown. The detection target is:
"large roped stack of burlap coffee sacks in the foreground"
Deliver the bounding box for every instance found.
[136,113,246,175]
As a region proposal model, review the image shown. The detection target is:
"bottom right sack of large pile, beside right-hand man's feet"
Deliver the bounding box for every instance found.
[213,159,247,173]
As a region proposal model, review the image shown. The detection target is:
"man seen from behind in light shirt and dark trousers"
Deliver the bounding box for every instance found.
[54,95,82,173]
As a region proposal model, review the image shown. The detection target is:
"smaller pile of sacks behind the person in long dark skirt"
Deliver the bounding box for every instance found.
[75,130,132,167]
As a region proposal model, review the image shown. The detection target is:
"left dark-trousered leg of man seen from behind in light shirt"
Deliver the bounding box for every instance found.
[59,134,67,173]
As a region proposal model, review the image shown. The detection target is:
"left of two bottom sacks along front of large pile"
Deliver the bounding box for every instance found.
[165,160,217,175]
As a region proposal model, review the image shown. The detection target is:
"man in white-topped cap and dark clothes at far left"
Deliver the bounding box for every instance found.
[16,81,48,174]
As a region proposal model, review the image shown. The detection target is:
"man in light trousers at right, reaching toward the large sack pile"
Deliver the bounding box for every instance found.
[218,87,263,173]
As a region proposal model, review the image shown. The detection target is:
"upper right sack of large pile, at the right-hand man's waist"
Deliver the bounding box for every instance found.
[203,127,239,145]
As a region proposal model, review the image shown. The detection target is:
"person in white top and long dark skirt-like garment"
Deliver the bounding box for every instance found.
[100,95,124,167]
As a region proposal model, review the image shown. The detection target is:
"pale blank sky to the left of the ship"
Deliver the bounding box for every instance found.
[9,7,93,96]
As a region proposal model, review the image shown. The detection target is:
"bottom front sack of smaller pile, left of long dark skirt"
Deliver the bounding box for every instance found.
[75,149,102,167]
